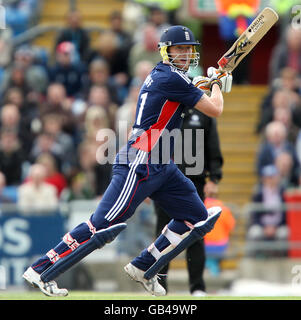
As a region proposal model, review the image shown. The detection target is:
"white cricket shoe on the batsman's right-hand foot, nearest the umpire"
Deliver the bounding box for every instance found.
[124,263,166,296]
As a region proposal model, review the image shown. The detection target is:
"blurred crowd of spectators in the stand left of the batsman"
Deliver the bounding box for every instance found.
[0,0,169,218]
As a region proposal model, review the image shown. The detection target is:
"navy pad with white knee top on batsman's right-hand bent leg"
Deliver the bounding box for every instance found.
[144,207,222,280]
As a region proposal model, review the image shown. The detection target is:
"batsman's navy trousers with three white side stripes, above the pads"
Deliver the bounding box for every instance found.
[91,156,207,230]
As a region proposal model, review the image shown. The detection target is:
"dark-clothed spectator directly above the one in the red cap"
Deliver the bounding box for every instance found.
[55,10,90,61]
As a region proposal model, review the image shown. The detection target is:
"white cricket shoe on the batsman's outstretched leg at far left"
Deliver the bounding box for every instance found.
[22,267,68,297]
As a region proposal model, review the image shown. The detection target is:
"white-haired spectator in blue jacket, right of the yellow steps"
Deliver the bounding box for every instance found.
[257,121,300,176]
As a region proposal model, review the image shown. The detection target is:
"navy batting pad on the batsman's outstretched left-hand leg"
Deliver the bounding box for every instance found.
[41,223,126,282]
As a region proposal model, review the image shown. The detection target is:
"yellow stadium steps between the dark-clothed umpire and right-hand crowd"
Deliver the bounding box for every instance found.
[218,86,267,205]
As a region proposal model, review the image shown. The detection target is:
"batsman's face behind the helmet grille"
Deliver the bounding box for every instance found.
[169,44,193,71]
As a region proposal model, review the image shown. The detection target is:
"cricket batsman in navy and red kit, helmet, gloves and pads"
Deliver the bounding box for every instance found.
[23,25,232,296]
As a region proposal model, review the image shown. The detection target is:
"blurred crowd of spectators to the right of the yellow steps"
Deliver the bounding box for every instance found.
[247,24,301,254]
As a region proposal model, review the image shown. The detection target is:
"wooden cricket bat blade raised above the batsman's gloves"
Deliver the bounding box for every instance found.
[217,7,278,72]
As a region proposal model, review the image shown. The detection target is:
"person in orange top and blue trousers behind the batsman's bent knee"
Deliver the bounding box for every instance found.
[204,195,235,276]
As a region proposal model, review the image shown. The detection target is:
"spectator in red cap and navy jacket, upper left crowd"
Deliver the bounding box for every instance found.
[49,41,86,97]
